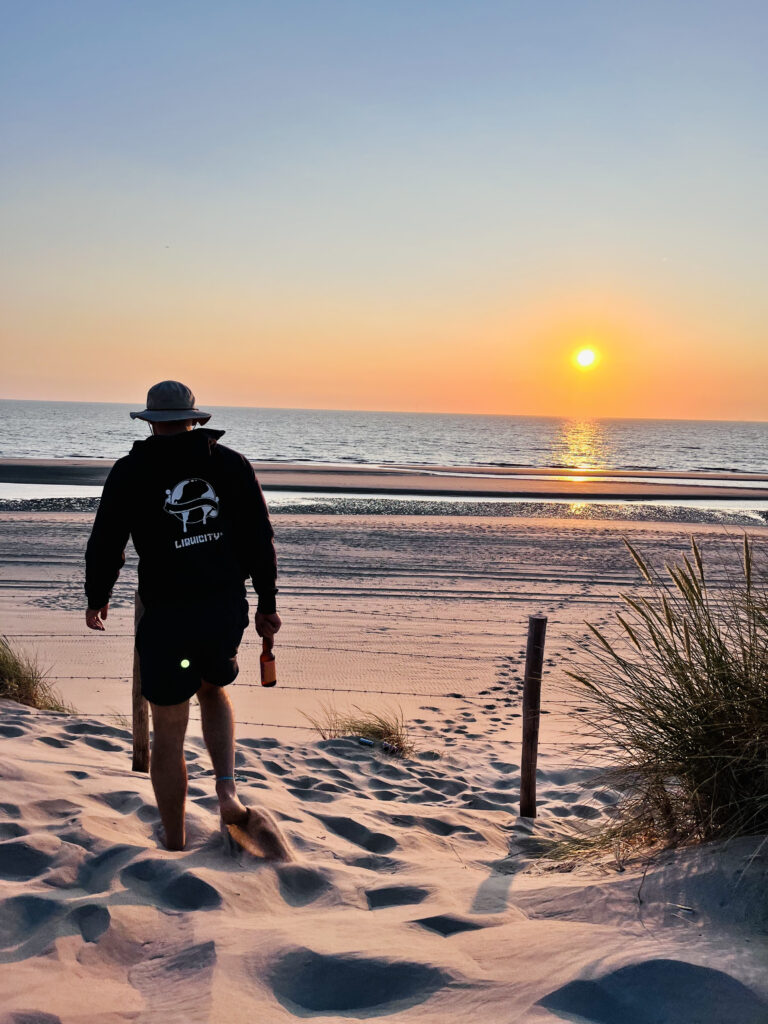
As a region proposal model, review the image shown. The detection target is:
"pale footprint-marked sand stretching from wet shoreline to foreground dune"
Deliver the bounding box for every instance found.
[0,512,768,1024]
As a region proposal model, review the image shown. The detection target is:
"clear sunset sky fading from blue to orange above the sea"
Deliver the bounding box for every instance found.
[0,0,768,420]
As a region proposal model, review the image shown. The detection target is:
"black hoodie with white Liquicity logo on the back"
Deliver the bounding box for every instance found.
[85,428,278,613]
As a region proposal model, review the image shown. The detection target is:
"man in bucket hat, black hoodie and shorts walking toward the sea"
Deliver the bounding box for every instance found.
[85,381,281,850]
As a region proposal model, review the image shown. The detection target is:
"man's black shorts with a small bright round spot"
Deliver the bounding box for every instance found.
[136,594,248,706]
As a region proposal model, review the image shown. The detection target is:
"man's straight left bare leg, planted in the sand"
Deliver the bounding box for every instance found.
[150,700,189,850]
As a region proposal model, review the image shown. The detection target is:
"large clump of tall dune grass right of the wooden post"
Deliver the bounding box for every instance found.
[568,537,768,845]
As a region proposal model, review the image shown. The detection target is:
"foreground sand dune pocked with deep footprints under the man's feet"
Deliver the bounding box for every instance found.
[0,701,768,1024]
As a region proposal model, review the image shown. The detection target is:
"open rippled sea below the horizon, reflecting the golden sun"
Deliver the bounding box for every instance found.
[0,399,768,473]
